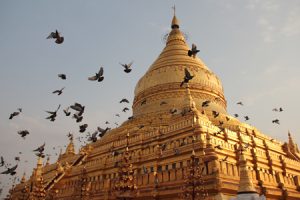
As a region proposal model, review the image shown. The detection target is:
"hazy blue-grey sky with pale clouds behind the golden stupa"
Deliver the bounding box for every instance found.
[0,0,300,197]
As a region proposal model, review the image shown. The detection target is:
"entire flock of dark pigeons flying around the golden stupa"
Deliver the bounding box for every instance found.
[0,34,283,197]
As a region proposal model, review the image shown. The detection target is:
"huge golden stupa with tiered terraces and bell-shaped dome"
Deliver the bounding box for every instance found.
[9,15,300,200]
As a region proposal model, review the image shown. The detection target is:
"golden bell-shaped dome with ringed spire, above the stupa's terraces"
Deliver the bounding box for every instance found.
[133,15,226,117]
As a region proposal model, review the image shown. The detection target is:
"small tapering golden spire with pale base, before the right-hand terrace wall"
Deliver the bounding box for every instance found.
[237,153,257,194]
